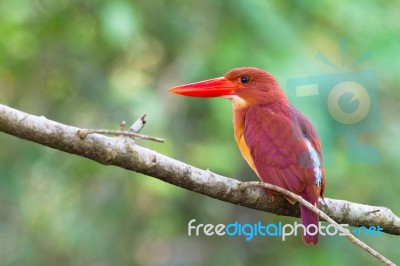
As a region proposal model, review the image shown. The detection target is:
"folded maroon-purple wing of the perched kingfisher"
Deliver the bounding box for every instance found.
[244,103,320,198]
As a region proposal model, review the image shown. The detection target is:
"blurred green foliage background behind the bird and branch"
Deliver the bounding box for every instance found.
[0,0,400,265]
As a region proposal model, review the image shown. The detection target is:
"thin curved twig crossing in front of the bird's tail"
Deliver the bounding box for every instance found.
[240,181,395,265]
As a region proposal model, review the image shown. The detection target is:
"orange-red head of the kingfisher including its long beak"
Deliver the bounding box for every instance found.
[169,67,286,105]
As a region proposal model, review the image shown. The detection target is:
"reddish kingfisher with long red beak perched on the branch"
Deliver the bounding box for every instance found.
[169,67,326,245]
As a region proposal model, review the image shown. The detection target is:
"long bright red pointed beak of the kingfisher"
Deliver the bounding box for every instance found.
[169,77,239,98]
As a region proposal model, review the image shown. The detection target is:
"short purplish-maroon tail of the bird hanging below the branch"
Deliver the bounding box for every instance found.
[300,193,319,245]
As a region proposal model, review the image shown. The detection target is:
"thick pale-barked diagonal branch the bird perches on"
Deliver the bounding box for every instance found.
[0,104,400,235]
